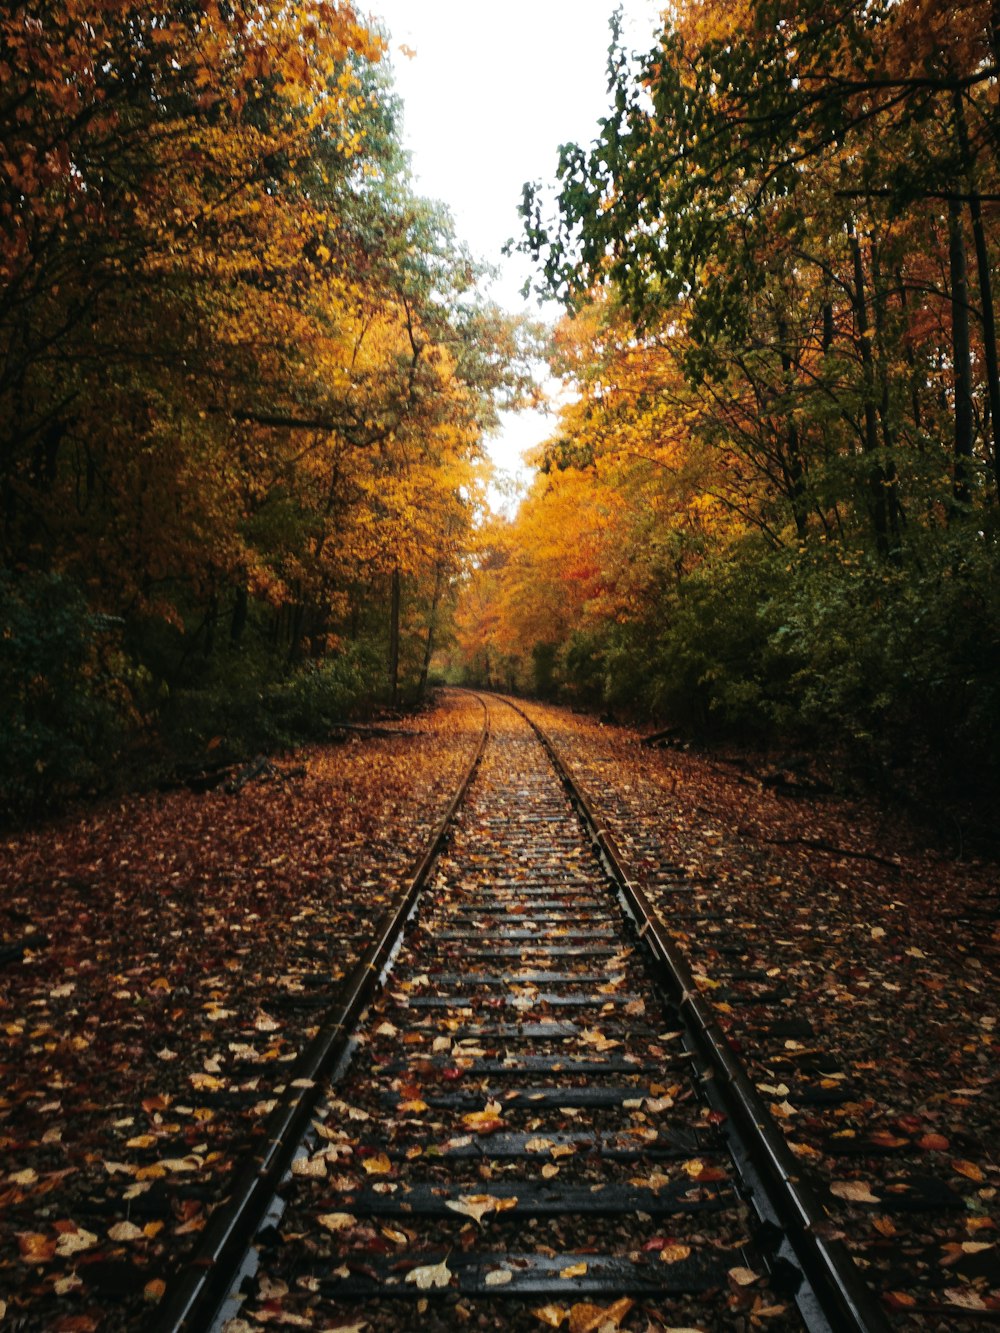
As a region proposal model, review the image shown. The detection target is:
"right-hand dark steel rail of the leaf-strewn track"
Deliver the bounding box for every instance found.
[504,698,892,1333]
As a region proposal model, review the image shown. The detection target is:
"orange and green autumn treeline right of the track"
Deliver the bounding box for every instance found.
[461,0,1000,788]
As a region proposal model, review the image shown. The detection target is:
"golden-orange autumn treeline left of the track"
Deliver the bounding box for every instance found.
[0,0,533,809]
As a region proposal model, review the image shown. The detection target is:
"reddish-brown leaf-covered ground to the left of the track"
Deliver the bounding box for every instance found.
[0,696,483,1333]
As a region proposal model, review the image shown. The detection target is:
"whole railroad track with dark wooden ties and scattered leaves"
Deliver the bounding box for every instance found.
[156,700,888,1333]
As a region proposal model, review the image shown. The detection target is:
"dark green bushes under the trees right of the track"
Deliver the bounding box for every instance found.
[576,533,1000,788]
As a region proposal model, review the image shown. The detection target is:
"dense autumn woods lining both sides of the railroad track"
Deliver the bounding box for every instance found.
[0,0,1000,812]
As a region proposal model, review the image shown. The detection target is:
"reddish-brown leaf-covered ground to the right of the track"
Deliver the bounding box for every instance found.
[520,706,1000,1329]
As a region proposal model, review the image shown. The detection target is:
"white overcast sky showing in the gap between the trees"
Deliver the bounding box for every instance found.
[359,0,663,501]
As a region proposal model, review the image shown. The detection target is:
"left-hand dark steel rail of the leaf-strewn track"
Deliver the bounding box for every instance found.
[151,694,489,1333]
